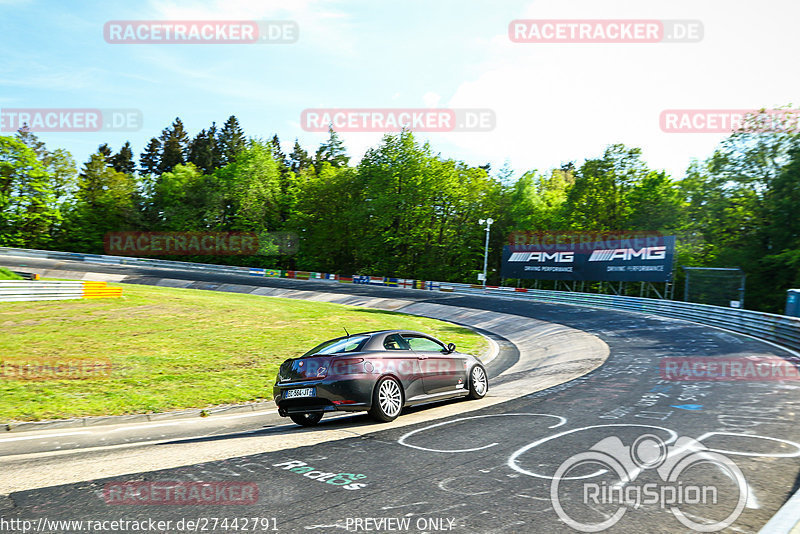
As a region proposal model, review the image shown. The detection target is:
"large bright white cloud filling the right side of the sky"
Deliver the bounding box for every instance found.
[434,0,800,177]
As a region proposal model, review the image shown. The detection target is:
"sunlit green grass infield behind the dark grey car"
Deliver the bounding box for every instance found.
[0,284,486,422]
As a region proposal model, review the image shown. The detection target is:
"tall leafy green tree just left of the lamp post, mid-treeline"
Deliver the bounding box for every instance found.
[355,132,500,279]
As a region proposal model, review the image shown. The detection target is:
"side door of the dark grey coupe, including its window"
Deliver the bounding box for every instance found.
[402,334,466,395]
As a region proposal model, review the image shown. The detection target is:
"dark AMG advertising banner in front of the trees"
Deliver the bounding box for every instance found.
[502,235,675,282]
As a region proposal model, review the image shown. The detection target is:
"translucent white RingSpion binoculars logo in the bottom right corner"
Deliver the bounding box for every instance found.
[550,434,749,532]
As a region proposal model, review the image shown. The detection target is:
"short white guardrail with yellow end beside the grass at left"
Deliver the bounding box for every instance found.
[0,280,122,302]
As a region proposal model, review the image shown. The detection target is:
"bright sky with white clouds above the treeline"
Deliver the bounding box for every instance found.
[0,0,800,178]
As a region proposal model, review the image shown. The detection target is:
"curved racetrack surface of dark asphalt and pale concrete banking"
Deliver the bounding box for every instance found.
[0,257,800,532]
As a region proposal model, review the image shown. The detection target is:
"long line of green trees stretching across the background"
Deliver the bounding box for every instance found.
[0,116,800,312]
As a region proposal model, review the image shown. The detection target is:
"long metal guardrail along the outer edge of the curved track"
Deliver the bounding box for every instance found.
[0,247,800,356]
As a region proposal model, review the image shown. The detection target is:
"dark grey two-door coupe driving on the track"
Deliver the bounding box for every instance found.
[272,330,489,426]
